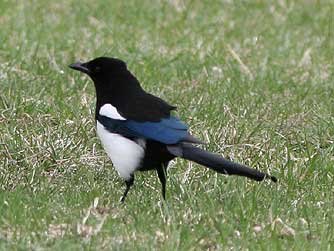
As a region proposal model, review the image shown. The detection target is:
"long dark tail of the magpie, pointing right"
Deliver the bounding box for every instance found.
[168,143,277,182]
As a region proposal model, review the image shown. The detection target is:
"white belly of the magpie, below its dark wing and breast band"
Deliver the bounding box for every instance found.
[96,121,145,180]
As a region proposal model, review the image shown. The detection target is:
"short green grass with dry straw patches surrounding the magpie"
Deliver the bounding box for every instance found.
[0,0,334,250]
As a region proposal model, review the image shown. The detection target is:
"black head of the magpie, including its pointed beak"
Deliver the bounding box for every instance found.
[69,57,127,81]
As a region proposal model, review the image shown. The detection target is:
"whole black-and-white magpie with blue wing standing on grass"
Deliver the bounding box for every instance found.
[69,57,277,202]
